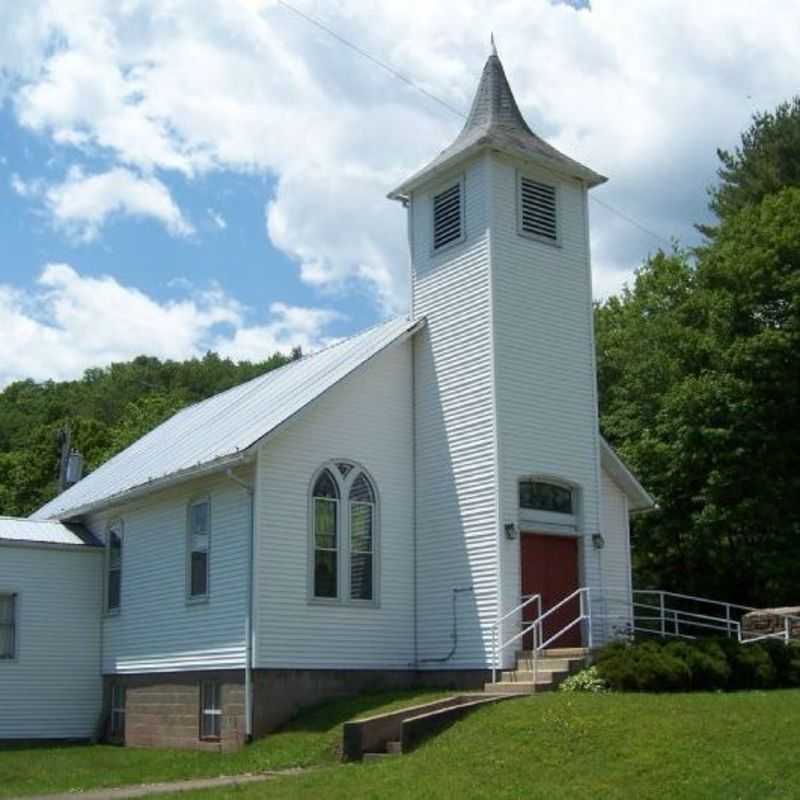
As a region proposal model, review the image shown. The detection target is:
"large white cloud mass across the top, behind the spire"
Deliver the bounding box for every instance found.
[0,0,800,308]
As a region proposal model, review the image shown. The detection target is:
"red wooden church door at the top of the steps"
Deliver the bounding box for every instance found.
[520,533,582,650]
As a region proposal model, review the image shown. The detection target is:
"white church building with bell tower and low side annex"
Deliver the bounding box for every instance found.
[0,54,653,747]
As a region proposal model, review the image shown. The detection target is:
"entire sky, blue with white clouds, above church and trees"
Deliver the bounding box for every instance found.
[0,0,800,386]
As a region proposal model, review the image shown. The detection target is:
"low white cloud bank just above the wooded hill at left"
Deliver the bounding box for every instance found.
[0,264,340,387]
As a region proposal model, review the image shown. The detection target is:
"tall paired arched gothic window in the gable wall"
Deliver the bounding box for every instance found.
[311,461,377,602]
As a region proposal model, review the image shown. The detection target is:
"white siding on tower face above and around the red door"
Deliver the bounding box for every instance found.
[491,156,601,662]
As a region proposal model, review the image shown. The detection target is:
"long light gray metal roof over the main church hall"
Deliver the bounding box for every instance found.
[32,318,422,519]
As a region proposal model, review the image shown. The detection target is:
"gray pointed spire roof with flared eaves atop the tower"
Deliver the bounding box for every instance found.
[389,48,606,200]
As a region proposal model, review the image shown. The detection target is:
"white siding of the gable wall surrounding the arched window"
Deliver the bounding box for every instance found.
[254,341,414,669]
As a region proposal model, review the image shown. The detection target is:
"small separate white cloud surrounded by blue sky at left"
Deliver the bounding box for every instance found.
[44,167,194,241]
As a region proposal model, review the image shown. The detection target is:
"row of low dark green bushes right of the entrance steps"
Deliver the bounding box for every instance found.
[561,639,800,692]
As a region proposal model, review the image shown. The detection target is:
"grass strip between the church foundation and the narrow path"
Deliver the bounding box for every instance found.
[0,692,443,798]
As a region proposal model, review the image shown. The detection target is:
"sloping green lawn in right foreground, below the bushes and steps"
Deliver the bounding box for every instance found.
[150,690,800,800]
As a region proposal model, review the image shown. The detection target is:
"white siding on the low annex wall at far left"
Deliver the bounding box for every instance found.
[0,544,103,739]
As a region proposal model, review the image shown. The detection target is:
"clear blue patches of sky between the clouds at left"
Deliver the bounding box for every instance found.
[0,104,376,336]
